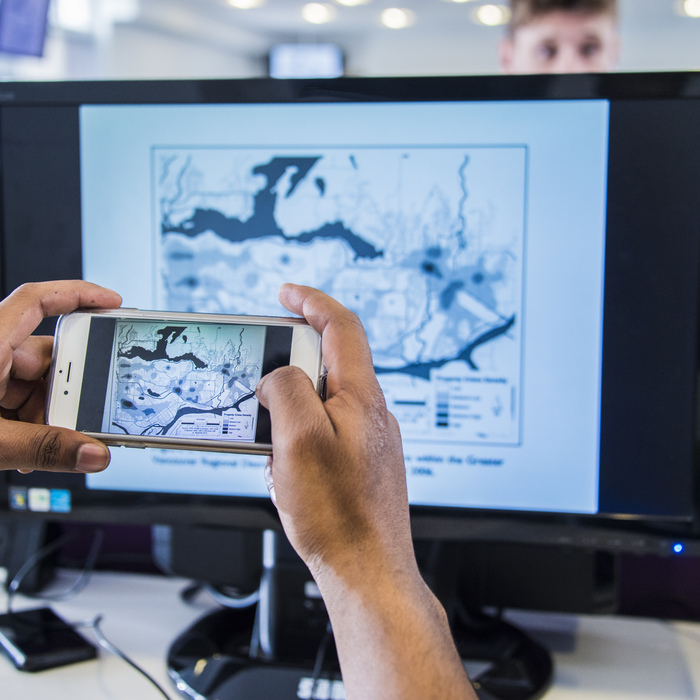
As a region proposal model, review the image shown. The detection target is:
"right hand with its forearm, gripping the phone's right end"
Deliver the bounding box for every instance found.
[257,285,476,700]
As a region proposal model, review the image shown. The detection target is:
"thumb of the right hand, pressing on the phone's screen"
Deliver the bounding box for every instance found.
[256,366,332,454]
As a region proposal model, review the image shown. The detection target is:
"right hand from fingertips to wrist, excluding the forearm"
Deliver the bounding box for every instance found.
[257,285,415,575]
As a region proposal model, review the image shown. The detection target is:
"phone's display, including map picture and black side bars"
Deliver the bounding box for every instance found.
[76,316,293,444]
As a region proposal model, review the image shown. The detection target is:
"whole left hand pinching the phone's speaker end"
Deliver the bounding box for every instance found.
[0,280,121,473]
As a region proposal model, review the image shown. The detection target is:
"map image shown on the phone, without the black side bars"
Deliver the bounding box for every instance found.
[102,319,266,441]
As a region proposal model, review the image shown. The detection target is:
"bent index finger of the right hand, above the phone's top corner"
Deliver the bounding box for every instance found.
[279,284,378,397]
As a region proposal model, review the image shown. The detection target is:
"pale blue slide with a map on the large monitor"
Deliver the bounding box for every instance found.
[80,101,609,513]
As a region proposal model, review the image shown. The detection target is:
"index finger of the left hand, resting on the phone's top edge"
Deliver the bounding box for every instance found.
[0,280,121,361]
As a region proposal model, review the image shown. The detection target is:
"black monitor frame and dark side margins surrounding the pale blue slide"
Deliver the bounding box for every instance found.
[0,68,700,553]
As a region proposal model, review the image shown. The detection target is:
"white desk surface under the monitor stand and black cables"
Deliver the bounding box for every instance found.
[0,573,700,700]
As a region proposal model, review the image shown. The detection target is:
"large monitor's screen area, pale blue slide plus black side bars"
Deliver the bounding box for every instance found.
[0,75,700,548]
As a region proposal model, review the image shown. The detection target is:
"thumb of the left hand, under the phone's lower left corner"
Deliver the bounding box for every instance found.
[0,420,110,473]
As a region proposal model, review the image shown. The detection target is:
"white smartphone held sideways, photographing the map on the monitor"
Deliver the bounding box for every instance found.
[46,309,325,454]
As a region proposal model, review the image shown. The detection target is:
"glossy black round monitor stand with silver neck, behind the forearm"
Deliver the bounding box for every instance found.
[167,532,552,700]
